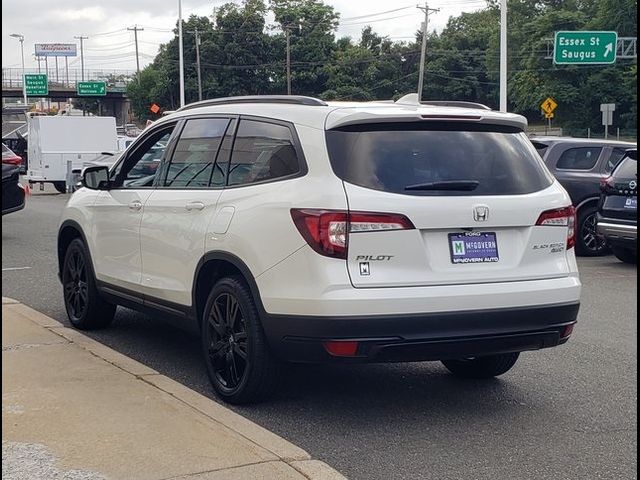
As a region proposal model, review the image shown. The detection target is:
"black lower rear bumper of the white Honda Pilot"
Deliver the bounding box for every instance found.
[263,302,579,363]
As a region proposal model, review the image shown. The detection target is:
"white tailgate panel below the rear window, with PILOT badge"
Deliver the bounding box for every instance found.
[345,184,569,287]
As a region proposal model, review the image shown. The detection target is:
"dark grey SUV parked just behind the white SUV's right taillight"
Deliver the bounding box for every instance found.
[531,136,635,256]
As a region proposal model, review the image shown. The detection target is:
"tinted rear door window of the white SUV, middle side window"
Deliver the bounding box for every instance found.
[164,118,229,188]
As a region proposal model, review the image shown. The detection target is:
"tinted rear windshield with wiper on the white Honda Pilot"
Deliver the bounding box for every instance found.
[327,122,553,196]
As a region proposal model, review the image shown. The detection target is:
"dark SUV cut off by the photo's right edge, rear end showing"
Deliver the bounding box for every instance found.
[598,149,638,264]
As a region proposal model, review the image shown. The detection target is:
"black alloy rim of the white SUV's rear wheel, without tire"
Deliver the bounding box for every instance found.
[208,293,247,392]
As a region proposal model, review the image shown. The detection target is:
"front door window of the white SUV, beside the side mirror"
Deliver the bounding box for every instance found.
[111,125,175,188]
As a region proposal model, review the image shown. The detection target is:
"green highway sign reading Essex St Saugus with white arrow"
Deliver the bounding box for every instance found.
[553,31,618,65]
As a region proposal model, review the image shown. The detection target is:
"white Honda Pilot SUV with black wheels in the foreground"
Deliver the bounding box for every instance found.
[58,95,581,403]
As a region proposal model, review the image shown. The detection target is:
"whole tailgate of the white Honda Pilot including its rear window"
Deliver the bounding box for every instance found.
[327,122,574,287]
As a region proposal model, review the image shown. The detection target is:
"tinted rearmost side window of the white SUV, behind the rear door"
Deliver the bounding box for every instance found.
[228,120,300,185]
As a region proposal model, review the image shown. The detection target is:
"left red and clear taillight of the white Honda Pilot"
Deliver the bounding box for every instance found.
[291,208,415,258]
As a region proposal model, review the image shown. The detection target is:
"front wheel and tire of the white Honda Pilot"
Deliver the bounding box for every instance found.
[62,238,116,330]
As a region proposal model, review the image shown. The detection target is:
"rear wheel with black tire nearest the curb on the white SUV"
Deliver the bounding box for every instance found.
[201,277,279,404]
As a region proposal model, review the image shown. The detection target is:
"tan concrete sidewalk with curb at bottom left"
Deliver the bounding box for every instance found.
[2,298,344,480]
